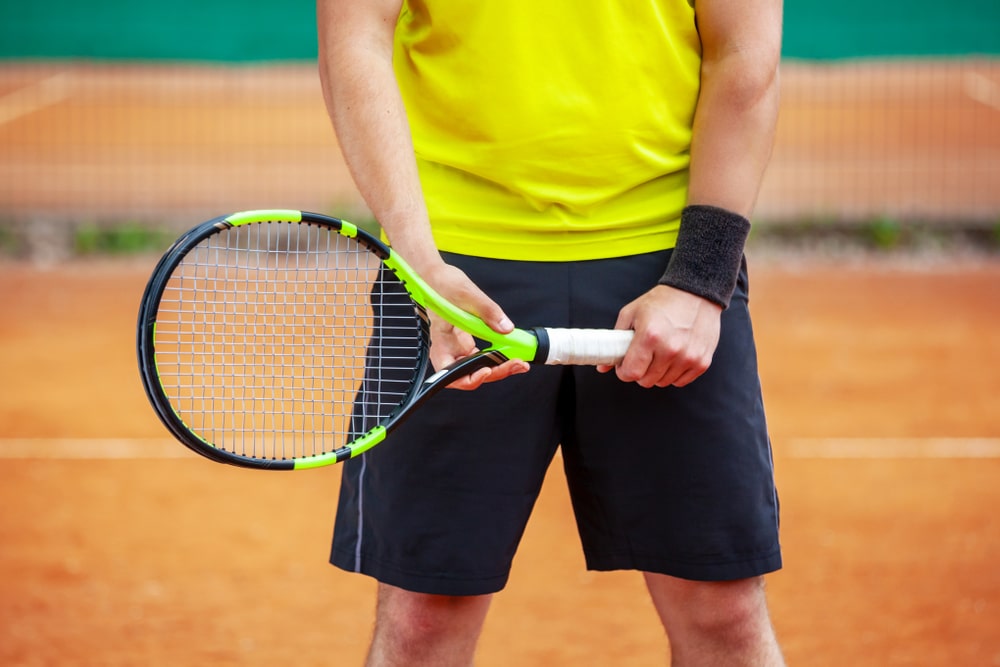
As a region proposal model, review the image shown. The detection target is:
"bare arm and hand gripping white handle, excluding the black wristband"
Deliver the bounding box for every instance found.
[617,0,781,387]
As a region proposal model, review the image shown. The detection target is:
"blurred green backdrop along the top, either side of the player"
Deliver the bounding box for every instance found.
[0,0,1000,61]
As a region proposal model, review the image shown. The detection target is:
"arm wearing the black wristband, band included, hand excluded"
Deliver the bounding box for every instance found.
[660,0,781,307]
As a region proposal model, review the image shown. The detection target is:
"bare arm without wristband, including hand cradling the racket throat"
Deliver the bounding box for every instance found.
[316,0,527,389]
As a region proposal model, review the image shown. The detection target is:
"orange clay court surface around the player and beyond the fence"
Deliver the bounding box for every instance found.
[0,61,1000,667]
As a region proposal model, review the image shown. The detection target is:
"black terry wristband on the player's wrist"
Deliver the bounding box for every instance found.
[657,204,750,308]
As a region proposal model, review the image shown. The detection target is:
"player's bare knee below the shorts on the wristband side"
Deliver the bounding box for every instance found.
[645,573,785,667]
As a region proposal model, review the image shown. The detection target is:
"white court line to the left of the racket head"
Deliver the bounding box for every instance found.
[0,438,195,460]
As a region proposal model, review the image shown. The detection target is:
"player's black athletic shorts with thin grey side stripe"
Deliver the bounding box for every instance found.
[330,251,781,595]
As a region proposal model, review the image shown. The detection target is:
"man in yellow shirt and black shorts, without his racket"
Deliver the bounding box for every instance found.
[317,0,782,666]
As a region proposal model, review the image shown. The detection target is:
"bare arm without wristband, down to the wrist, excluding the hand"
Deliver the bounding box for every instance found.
[317,0,441,272]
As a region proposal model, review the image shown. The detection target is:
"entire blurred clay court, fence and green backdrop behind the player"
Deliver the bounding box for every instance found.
[0,0,1000,667]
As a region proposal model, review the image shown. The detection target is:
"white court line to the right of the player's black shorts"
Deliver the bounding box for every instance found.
[781,438,1000,459]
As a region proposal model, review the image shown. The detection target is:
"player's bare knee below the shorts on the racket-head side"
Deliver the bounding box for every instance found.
[365,584,493,667]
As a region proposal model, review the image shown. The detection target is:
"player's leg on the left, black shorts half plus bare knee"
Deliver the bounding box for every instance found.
[331,254,570,666]
